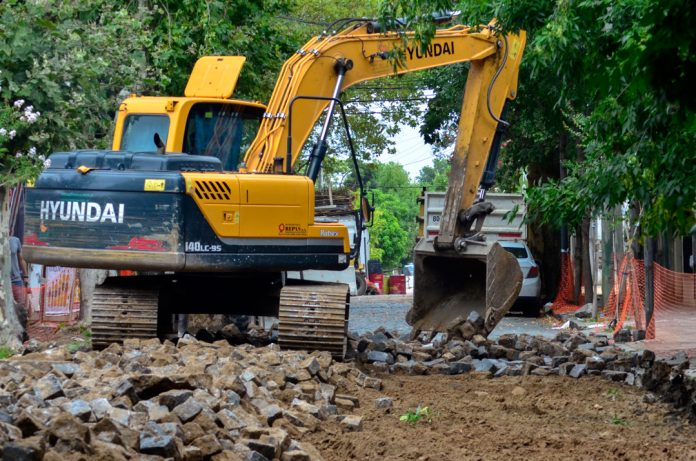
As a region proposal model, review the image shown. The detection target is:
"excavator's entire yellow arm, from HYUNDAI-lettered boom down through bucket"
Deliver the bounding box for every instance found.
[245,20,526,337]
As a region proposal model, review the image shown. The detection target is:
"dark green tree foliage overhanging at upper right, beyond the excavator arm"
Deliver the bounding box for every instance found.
[380,0,696,239]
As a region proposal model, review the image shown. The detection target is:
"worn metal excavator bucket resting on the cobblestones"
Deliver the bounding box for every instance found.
[406,238,522,339]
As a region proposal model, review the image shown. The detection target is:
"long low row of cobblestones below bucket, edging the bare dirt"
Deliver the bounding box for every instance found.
[350,329,696,421]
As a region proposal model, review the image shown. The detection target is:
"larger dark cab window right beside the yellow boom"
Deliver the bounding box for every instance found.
[183,103,263,171]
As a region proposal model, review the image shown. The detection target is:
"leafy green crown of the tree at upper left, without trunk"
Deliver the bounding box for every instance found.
[0,0,153,165]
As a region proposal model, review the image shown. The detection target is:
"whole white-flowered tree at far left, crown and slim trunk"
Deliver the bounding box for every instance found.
[0,0,155,346]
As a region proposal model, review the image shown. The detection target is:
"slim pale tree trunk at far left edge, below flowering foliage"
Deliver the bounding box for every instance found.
[0,186,22,350]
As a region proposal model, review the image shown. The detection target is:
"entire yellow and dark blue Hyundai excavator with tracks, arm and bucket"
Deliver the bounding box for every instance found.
[24,19,525,356]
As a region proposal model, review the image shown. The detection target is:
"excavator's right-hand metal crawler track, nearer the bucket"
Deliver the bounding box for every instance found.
[278,284,350,358]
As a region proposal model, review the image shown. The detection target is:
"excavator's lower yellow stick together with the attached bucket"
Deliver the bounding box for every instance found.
[407,31,526,338]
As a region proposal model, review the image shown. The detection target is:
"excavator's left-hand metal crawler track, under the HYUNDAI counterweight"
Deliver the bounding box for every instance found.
[92,285,159,348]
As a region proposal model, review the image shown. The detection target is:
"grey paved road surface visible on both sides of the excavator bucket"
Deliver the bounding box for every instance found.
[349,295,557,339]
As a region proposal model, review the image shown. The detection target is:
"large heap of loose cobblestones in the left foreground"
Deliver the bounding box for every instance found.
[0,336,381,461]
